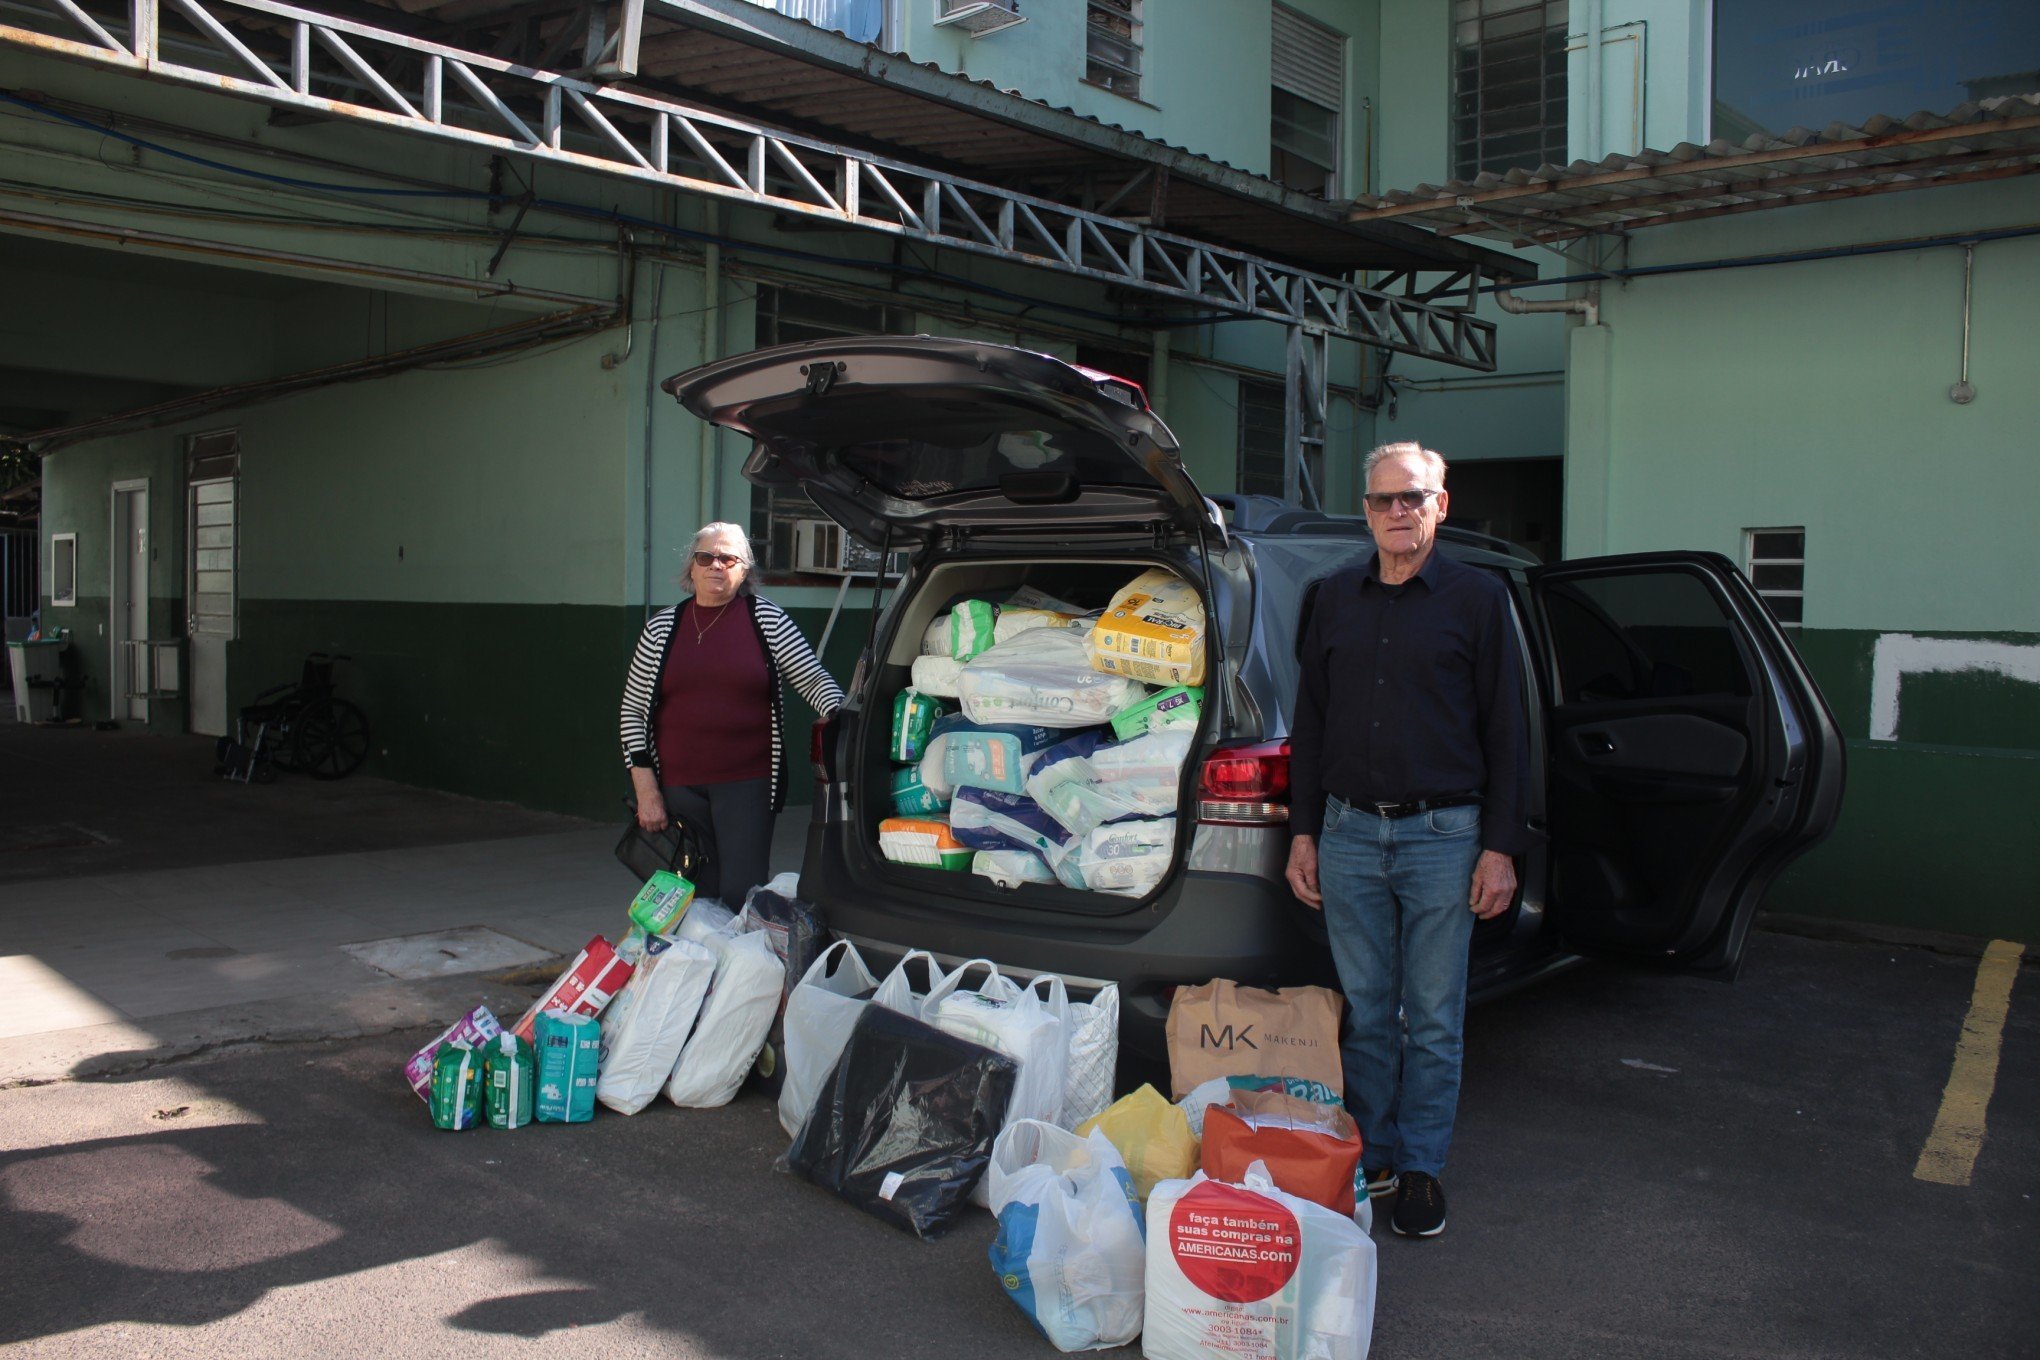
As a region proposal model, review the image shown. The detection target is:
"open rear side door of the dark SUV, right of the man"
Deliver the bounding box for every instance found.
[1528,553,1842,977]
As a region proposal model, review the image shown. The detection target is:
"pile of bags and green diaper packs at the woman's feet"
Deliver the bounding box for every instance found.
[404,873,822,1130]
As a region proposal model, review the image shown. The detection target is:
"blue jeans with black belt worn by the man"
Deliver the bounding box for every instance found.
[1318,797,1481,1176]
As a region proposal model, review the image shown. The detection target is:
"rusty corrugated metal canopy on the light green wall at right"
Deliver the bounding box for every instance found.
[1353,96,2040,245]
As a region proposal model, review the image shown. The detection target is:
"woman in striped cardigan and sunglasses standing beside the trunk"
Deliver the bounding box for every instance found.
[622,522,843,907]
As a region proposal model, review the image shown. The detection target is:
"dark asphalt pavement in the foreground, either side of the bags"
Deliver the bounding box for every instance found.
[0,934,2040,1360]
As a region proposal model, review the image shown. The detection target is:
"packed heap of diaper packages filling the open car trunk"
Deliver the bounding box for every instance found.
[877,569,1204,897]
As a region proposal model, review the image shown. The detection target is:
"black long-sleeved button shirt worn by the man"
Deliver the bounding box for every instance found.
[1289,551,1532,854]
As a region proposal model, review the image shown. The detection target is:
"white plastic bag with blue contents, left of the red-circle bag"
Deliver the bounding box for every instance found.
[985,1119,1146,1352]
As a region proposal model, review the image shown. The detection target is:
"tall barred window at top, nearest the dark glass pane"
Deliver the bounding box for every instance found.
[1452,0,1567,179]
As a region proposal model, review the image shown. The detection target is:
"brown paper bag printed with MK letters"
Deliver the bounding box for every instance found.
[1169,979,1346,1097]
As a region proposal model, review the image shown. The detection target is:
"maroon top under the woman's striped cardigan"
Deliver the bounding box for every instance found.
[657,595,771,785]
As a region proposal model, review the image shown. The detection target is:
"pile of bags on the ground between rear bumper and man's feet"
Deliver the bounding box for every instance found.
[779,942,1375,1360]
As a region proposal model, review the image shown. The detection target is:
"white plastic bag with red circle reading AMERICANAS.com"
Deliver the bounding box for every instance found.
[1140,1162,1375,1360]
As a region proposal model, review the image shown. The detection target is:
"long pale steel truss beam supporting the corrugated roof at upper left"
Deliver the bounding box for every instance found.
[0,0,1495,371]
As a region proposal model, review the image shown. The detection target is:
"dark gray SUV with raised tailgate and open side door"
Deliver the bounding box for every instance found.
[665,336,1842,1062]
